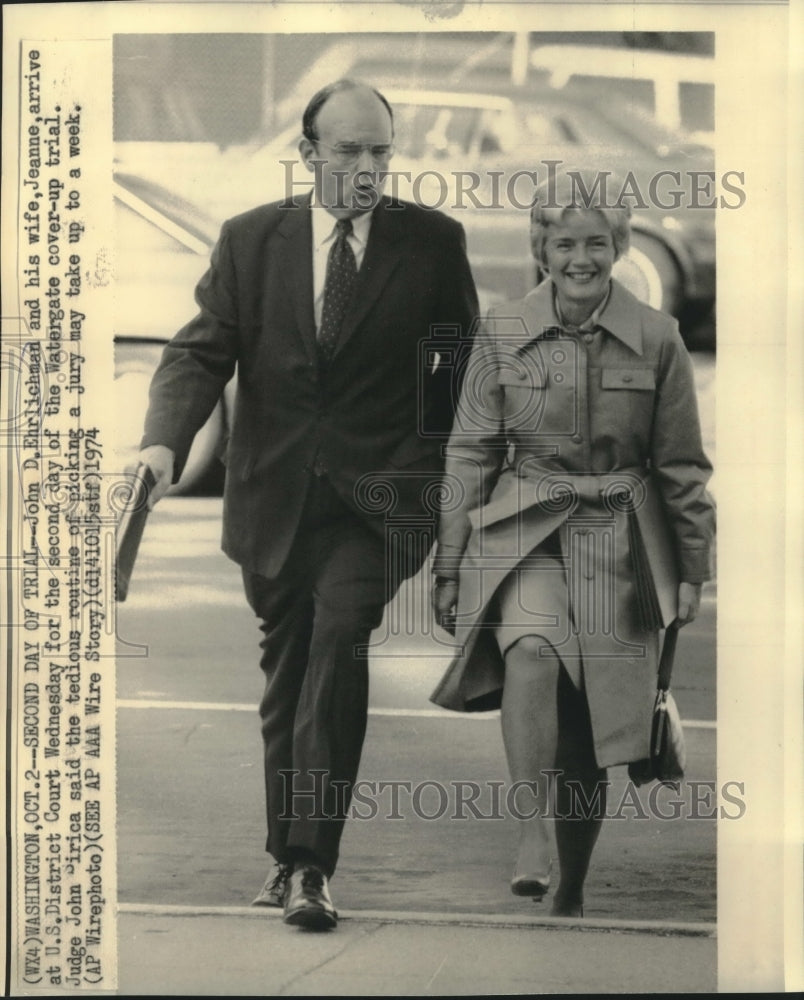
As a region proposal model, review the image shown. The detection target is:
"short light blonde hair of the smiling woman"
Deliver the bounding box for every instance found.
[530,168,631,267]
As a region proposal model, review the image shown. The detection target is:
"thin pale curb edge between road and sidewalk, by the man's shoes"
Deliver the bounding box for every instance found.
[117,903,717,937]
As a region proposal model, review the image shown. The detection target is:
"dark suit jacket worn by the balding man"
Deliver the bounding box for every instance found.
[143,193,477,576]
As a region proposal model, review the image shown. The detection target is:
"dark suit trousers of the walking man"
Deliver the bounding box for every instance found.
[243,476,393,876]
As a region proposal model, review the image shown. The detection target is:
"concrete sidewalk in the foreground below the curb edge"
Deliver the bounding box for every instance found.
[118,904,717,996]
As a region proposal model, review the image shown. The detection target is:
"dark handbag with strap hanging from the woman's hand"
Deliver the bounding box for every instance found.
[628,622,687,786]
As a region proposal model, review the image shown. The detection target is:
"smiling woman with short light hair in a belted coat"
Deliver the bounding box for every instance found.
[432,166,714,917]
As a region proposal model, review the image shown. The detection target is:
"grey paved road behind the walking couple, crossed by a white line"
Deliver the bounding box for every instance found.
[118,490,716,921]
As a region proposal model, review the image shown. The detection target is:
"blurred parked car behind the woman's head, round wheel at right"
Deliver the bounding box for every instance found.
[374,87,715,330]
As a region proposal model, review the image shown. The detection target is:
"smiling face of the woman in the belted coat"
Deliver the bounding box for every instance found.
[544,209,616,314]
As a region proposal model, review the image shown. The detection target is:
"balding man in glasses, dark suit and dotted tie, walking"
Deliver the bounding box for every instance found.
[140,80,477,929]
